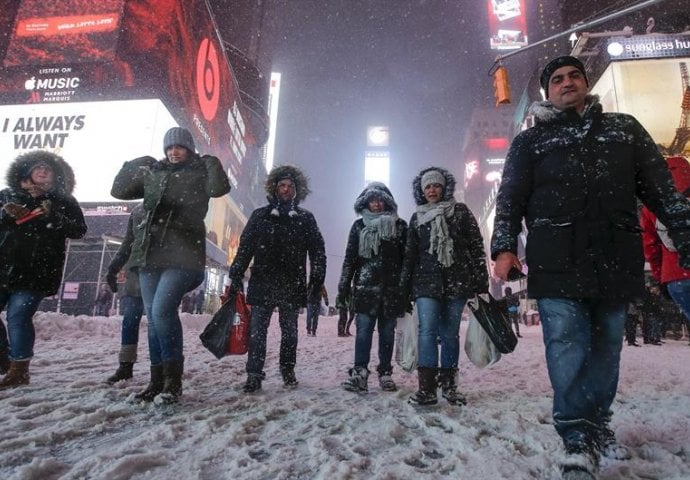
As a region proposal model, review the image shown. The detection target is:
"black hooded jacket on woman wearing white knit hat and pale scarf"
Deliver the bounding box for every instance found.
[401,167,489,300]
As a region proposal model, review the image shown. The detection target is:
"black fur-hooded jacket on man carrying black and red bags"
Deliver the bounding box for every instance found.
[229,165,326,307]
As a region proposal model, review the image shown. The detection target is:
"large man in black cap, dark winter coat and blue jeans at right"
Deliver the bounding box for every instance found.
[491,56,690,478]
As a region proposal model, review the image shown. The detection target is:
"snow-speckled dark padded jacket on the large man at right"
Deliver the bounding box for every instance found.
[491,96,690,300]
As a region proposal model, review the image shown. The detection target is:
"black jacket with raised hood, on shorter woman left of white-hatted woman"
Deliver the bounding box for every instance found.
[338,182,407,318]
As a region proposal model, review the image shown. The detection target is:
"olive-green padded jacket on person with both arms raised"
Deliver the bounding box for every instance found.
[111,154,230,270]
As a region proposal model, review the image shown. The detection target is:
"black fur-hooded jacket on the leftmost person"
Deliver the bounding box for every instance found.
[0,150,86,296]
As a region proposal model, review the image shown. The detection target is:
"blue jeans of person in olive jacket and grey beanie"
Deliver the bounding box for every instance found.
[139,268,204,365]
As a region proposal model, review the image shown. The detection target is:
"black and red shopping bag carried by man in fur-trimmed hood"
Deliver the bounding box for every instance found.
[199,292,250,359]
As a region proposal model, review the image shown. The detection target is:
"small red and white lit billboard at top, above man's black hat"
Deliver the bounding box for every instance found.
[487,0,527,50]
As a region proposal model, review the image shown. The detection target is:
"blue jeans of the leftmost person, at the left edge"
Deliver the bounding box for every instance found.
[0,289,44,361]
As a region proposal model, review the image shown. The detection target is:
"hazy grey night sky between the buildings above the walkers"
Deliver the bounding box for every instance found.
[266,0,494,288]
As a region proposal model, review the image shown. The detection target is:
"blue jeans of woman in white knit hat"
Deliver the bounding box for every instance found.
[415,297,467,368]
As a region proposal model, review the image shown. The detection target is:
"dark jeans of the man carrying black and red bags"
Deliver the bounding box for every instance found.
[246,305,299,375]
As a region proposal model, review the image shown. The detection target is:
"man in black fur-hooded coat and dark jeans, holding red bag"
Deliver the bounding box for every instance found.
[224,165,326,393]
